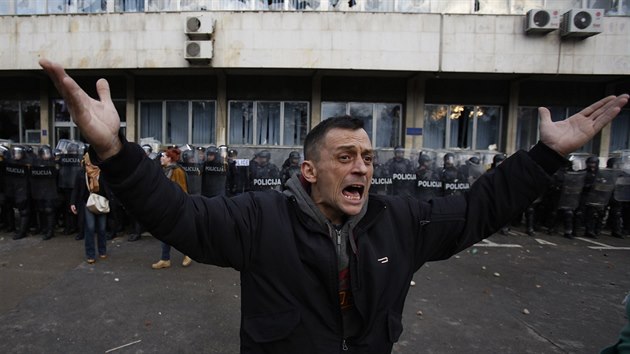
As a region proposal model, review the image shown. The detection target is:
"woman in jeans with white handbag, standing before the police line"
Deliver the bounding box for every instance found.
[70,154,109,264]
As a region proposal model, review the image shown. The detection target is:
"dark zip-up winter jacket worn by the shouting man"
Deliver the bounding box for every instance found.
[91,143,566,353]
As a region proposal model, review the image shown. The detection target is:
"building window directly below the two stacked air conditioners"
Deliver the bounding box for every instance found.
[138,100,216,145]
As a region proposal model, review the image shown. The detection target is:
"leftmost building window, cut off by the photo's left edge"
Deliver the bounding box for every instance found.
[0,101,41,143]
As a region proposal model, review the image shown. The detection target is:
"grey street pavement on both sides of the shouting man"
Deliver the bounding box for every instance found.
[0,228,630,354]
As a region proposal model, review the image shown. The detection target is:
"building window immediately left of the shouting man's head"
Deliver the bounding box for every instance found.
[228,101,309,146]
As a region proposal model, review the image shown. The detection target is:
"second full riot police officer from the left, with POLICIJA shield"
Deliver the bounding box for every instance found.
[30,145,59,240]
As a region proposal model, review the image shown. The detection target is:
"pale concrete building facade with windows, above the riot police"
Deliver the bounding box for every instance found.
[0,0,630,166]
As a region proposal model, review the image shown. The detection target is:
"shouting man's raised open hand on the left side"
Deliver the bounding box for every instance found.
[39,59,122,160]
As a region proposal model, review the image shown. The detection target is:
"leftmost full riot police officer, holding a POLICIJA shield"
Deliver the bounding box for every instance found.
[5,145,31,240]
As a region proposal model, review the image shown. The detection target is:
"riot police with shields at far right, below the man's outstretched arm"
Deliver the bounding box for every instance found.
[526,151,630,238]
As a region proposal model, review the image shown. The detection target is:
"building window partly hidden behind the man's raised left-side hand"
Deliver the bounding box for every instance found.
[51,99,127,145]
